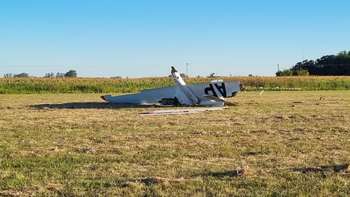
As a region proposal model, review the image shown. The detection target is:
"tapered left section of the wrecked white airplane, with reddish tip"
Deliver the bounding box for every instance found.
[101,86,176,104]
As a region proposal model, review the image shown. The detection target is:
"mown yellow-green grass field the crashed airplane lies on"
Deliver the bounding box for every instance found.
[0,91,350,196]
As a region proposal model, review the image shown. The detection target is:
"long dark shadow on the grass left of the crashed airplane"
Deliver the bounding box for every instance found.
[29,102,157,110]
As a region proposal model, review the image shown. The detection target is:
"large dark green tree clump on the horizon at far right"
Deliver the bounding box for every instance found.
[276,51,350,76]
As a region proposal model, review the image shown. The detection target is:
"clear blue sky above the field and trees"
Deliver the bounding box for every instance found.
[0,0,350,78]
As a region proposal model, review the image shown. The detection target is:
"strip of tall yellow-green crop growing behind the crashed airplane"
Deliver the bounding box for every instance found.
[0,76,350,94]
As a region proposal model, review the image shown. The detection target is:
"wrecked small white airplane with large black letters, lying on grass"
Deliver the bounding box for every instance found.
[101,67,241,107]
